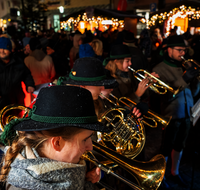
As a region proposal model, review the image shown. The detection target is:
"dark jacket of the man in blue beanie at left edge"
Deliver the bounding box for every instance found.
[0,54,35,108]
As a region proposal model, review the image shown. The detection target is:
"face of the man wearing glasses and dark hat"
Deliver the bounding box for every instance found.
[168,46,186,61]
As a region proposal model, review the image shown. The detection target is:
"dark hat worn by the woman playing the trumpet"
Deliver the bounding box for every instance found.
[103,44,131,66]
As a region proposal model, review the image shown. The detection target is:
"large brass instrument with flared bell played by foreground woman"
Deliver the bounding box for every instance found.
[82,142,166,190]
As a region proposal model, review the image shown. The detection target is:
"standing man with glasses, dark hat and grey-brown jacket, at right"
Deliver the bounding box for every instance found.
[153,36,199,186]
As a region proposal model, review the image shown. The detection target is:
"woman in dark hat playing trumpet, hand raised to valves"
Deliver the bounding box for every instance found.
[103,45,157,103]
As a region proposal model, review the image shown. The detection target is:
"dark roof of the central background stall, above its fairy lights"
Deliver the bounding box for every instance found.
[60,8,144,21]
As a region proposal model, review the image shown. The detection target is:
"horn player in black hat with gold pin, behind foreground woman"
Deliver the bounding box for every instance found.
[58,57,142,115]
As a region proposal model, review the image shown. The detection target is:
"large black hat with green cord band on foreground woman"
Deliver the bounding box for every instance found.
[13,86,109,132]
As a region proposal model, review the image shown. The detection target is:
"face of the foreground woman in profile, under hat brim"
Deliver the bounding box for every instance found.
[58,129,93,164]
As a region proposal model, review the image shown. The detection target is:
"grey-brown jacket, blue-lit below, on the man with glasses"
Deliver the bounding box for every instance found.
[153,60,199,119]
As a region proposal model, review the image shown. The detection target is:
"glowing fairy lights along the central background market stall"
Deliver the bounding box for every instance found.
[60,13,124,30]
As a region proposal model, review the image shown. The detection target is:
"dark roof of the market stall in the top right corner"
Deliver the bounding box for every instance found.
[150,1,200,17]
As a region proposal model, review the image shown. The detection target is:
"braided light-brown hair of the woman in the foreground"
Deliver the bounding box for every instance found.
[0,127,84,181]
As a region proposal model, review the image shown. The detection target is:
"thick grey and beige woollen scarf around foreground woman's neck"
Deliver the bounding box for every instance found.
[6,147,98,190]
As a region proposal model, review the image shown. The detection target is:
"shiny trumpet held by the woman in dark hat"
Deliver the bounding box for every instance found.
[128,66,180,97]
